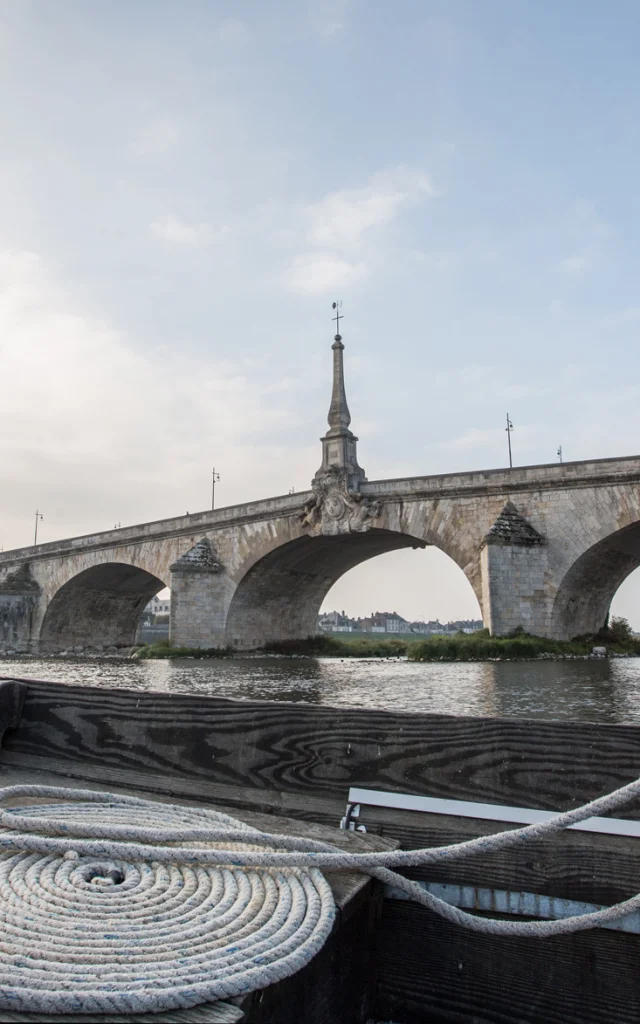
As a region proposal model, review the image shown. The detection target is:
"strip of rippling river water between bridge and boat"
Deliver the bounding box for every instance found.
[0,657,640,722]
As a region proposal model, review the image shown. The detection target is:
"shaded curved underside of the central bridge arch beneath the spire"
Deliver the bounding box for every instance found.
[226,528,479,647]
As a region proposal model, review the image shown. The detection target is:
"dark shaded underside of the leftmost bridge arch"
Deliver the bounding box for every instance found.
[40,562,166,651]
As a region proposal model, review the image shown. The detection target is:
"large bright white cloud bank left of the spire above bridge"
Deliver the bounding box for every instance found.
[0,251,319,550]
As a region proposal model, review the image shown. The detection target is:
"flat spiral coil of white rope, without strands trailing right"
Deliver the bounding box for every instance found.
[0,786,335,1014]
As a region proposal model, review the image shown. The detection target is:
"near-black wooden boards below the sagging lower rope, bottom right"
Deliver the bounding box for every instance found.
[375,900,640,1024]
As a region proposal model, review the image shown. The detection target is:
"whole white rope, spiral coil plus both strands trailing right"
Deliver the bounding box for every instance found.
[0,779,640,1014]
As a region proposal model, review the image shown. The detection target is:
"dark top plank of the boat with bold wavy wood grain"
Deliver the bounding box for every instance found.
[3,681,640,817]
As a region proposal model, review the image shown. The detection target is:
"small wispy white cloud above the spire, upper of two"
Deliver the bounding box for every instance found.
[306,167,437,246]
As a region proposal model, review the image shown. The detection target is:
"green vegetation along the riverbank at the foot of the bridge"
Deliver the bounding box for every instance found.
[133,618,640,662]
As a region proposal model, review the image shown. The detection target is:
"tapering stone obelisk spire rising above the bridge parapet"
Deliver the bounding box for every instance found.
[315,302,366,490]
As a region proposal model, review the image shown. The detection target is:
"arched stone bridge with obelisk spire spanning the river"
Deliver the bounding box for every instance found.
[0,336,640,651]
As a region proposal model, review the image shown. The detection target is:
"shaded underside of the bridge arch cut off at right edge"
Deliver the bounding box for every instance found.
[550,521,640,640]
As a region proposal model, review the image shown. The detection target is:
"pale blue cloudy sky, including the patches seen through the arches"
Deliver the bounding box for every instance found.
[0,0,640,629]
